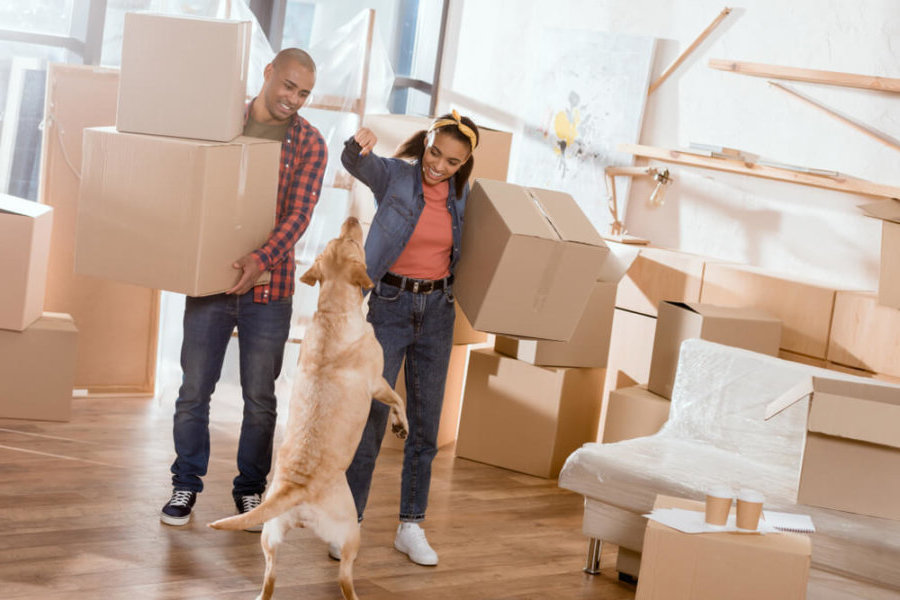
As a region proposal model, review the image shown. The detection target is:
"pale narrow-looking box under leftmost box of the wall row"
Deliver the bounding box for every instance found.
[597,308,656,442]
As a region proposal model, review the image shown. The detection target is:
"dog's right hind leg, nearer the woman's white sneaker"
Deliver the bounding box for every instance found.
[306,480,359,600]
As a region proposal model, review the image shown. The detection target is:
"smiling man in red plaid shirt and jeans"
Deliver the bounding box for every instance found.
[160,48,327,530]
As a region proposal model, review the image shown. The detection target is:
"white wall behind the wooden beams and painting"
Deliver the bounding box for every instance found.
[438,0,900,289]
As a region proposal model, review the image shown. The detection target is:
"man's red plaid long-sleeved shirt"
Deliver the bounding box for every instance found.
[247,103,328,304]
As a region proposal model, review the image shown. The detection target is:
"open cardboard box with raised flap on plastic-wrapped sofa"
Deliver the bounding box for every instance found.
[766,377,900,519]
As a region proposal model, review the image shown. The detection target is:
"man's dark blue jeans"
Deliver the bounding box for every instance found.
[172,290,291,497]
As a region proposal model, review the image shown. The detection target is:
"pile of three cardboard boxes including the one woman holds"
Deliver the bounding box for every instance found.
[455,179,616,477]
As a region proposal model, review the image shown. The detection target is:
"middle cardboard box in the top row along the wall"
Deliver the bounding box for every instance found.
[700,263,835,358]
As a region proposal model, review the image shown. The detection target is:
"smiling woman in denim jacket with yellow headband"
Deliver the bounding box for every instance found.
[338,111,478,565]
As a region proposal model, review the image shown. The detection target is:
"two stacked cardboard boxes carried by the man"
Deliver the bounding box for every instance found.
[75,13,281,296]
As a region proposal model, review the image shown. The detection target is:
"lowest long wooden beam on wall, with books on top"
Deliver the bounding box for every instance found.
[618,144,900,200]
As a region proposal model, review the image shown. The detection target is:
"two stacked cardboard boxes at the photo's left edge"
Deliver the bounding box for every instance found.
[0,194,78,421]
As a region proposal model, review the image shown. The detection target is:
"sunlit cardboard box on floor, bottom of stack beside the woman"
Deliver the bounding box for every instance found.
[456,349,604,478]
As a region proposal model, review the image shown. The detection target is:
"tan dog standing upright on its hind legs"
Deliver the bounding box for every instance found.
[209,217,409,600]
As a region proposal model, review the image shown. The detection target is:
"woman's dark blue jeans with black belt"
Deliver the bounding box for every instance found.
[347,282,456,522]
